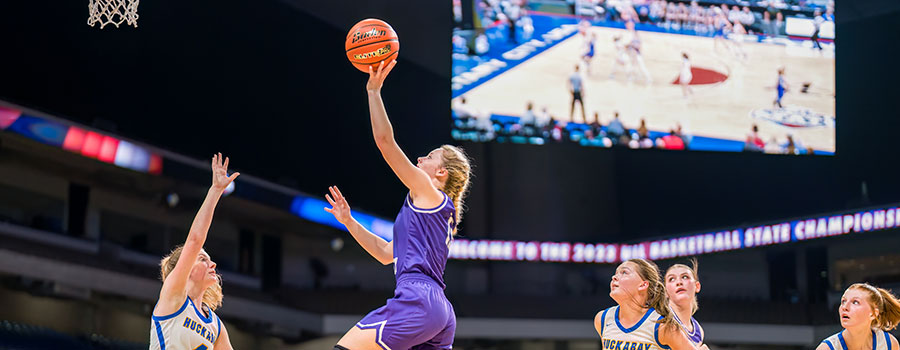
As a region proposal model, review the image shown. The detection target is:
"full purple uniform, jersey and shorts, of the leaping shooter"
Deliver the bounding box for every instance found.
[356,192,456,350]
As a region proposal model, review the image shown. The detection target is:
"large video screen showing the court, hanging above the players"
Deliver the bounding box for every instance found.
[451,0,835,155]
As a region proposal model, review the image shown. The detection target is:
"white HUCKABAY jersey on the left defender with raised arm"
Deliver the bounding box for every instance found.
[150,297,222,350]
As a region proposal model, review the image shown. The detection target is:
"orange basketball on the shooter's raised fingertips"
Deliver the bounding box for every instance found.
[344,18,400,73]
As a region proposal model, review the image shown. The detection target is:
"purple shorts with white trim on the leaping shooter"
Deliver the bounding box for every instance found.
[356,274,456,350]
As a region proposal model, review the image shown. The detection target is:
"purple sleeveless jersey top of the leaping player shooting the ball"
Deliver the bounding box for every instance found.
[393,192,456,288]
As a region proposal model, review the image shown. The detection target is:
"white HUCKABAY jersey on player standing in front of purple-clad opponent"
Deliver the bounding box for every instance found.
[600,306,669,350]
